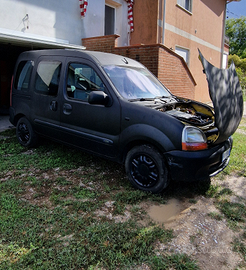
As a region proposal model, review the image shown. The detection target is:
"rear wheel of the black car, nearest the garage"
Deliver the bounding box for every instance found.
[16,117,38,147]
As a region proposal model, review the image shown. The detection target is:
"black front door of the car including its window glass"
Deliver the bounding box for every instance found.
[61,59,120,158]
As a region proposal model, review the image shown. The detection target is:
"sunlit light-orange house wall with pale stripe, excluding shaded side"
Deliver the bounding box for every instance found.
[164,0,225,102]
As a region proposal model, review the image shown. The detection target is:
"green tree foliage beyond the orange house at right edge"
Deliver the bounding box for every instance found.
[226,16,246,58]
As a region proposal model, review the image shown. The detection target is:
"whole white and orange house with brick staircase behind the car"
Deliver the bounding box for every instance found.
[0,0,237,112]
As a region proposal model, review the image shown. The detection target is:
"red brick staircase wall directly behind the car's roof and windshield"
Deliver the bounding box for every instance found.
[82,35,196,99]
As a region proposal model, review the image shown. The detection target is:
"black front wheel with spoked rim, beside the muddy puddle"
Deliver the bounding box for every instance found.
[125,145,168,193]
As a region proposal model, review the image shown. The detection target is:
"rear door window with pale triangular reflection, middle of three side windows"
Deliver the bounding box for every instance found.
[35,61,61,96]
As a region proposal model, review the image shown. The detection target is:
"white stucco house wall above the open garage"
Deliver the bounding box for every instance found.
[0,0,128,46]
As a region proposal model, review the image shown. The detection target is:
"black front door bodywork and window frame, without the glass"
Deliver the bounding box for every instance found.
[60,58,121,159]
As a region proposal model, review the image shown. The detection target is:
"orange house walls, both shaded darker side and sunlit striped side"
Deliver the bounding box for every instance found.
[130,0,226,102]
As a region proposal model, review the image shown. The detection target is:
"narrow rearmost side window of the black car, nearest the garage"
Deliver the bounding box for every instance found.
[14,61,33,91]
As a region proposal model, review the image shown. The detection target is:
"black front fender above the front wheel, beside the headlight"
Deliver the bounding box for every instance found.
[120,101,184,152]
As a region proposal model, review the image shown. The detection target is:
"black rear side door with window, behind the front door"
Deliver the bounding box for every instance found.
[32,56,62,139]
